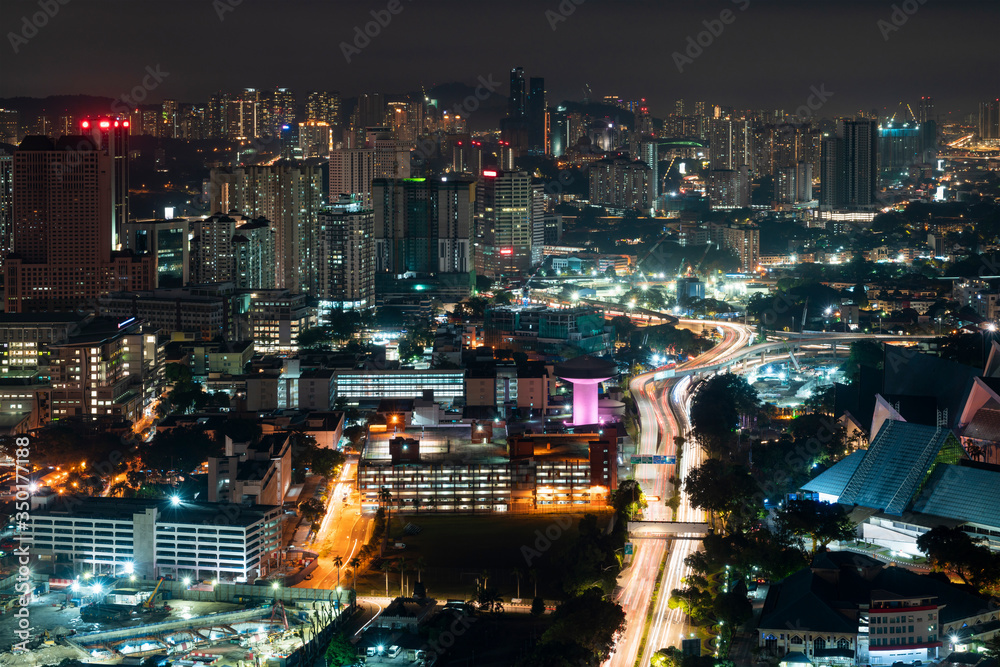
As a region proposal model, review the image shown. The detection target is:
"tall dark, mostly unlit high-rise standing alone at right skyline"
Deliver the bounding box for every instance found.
[820,118,878,210]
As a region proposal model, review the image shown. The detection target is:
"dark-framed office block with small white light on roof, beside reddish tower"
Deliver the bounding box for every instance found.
[122,218,191,288]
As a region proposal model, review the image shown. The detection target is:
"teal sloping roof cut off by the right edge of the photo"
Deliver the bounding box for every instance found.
[913,465,1000,529]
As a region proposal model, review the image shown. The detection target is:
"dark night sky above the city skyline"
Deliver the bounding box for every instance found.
[0,0,1000,116]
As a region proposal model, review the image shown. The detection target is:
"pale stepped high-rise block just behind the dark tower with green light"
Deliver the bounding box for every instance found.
[330,128,410,208]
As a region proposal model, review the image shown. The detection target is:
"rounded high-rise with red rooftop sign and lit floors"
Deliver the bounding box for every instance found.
[475,169,545,278]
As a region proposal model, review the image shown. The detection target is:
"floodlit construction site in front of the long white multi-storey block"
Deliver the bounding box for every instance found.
[0,579,353,667]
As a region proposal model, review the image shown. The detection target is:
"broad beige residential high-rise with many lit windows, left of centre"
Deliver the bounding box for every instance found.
[210,160,324,292]
